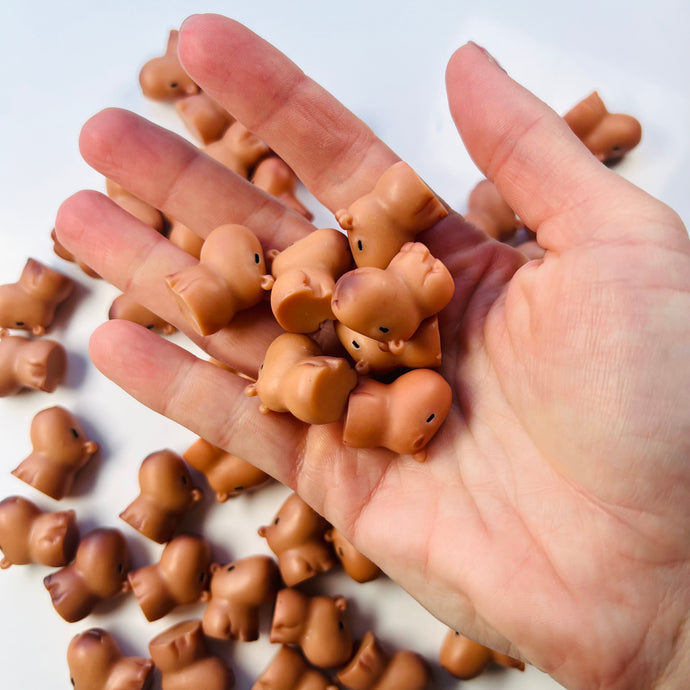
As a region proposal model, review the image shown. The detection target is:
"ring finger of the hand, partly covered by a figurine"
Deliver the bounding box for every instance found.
[55,192,281,376]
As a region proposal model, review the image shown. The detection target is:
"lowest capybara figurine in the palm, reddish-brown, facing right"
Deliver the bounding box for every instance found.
[343,369,453,462]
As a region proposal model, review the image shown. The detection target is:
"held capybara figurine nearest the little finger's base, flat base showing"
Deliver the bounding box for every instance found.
[245,333,357,424]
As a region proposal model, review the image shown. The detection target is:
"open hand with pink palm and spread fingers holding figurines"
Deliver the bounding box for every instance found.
[56,16,690,690]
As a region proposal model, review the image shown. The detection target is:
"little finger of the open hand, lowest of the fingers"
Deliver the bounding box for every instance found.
[89,320,305,483]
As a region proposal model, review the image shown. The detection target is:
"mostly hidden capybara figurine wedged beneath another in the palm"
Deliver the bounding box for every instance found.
[335,315,442,376]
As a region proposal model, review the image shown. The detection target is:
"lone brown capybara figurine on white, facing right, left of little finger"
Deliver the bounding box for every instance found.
[12,405,98,500]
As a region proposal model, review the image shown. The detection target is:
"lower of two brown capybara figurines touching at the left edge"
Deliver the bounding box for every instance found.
[0,328,67,397]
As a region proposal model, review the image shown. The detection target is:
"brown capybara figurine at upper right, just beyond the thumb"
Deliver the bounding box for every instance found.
[563,91,642,165]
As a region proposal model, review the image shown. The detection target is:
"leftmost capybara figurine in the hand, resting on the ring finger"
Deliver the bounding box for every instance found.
[166,224,273,335]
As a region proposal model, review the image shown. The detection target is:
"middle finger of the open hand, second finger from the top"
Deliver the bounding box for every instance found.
[79,108,313,248]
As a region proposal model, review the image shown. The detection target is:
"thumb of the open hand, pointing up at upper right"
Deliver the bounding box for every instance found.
[446,43,630,249]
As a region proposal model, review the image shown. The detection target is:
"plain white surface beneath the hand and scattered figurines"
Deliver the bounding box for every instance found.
[0,0,690,690]
